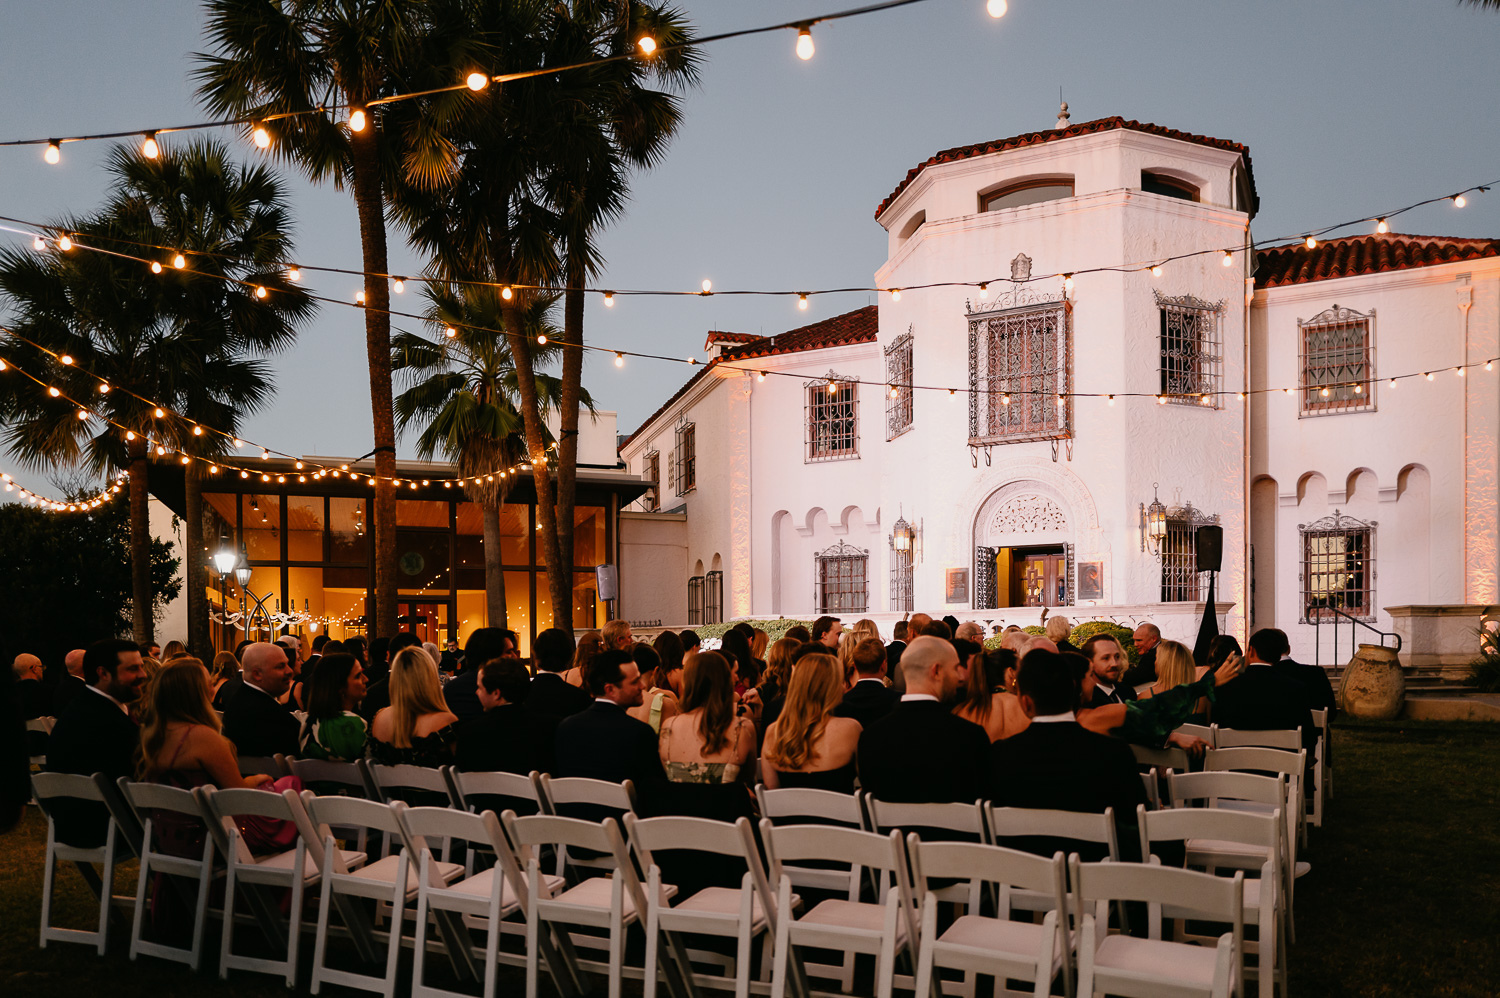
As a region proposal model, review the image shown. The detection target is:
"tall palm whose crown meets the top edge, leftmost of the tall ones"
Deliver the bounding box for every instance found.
[197,0,465,635]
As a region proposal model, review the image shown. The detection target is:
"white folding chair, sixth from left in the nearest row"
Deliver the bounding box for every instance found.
[501,816,690,998]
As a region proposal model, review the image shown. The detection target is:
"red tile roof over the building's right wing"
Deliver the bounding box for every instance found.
[1256,233,1500,288]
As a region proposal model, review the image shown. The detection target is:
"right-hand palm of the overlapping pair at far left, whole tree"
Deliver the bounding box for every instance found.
[110,141,317,654]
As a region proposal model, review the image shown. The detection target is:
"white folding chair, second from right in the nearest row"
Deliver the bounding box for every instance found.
[906,834,1073,998]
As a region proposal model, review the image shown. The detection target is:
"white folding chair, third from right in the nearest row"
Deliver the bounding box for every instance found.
[761,819,917,998]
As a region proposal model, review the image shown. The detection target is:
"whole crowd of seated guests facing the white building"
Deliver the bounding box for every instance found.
[14,614,1334,864]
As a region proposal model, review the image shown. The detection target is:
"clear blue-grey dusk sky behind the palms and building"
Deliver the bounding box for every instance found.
[0,0,1500,492]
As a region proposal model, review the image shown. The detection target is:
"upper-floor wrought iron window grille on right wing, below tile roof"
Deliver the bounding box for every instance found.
[1298,305,1376,416]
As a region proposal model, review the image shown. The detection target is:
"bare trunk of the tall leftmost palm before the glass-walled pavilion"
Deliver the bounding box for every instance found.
[350,122,396,638]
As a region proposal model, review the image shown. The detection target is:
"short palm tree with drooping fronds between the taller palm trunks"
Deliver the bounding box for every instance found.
[392,288,570,627]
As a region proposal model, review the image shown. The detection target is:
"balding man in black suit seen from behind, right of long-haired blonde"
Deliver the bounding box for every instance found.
[857,636,990,804]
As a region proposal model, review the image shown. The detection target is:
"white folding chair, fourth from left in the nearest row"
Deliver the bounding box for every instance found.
[302,791,468,995]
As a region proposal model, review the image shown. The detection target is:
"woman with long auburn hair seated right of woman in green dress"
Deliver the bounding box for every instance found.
[365,647,459,768]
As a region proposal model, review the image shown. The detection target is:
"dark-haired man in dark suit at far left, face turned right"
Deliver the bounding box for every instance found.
[47,638,144,848]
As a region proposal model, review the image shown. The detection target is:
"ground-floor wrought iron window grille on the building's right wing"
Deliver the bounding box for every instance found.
[1298,509,1379,624]
